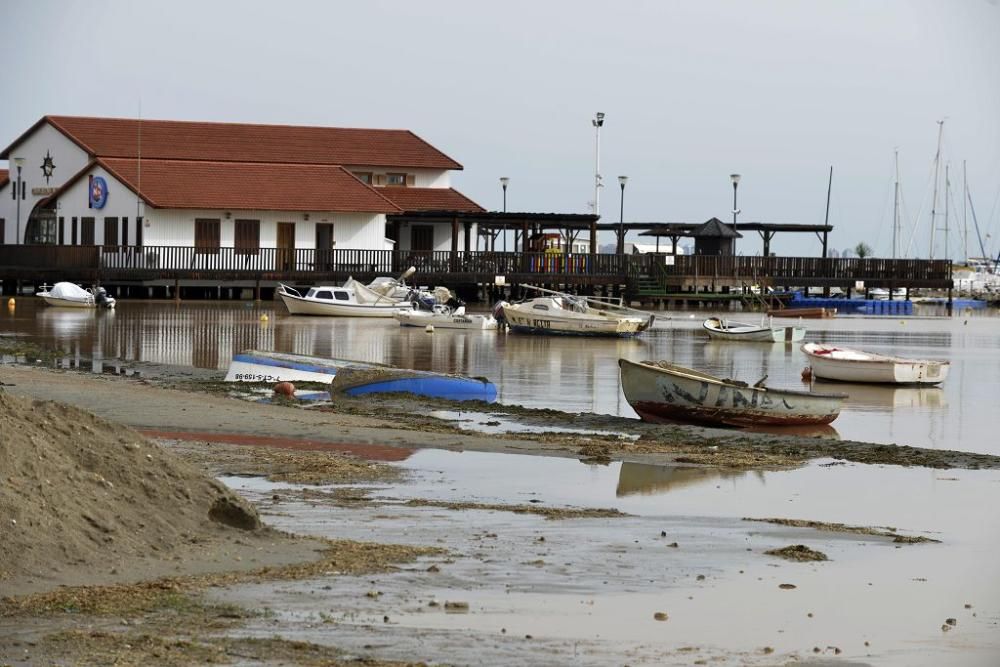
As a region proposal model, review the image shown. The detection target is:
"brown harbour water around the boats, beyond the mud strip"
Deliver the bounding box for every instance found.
[0,298,1000,454]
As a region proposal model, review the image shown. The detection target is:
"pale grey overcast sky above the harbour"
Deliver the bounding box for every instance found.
[0,0,1000,259]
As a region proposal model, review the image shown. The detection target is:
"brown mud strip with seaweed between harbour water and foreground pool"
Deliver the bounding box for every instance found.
[0,366,1000,469]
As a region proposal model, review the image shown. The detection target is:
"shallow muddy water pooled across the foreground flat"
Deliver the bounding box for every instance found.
[213,450,1000,666]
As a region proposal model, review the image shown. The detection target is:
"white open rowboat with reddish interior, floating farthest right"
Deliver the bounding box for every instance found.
[802,343,949,384]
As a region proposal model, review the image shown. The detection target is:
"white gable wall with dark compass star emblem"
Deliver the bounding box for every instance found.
[0,123,90,244]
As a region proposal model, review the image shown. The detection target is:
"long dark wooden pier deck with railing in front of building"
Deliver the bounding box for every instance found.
[0,246,952,296]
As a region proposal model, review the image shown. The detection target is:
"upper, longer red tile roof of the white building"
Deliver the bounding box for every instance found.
[0,116,462,169]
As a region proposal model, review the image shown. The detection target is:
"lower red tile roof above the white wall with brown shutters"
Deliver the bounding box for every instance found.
[83,158,400,213]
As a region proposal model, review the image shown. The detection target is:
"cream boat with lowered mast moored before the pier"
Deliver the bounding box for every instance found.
[494,285,654,336]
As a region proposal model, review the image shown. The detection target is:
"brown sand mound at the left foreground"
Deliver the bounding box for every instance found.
[0,390,261,589]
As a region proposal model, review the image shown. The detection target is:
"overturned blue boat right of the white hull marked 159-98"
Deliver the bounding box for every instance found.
[332,366,497,403]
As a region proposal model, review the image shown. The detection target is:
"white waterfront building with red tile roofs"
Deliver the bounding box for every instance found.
[0,116,483,253]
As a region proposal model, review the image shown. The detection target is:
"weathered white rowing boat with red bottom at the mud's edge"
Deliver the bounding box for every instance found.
[618,359,847,426]
